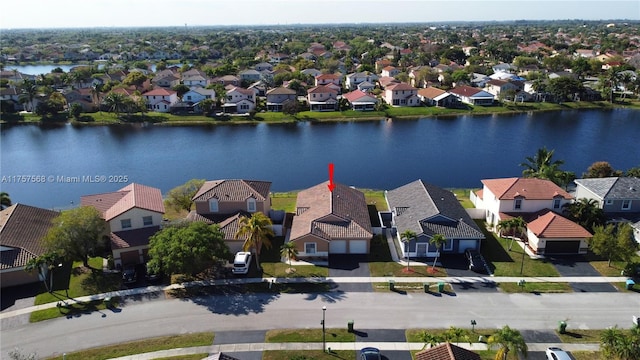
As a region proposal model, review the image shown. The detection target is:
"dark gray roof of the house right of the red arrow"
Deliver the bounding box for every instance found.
[386,180,484,239]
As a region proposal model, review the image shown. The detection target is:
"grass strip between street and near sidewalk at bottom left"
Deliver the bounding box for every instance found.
[45,332,214,360]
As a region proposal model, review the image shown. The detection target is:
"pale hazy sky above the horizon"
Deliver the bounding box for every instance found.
[0,0,640,29]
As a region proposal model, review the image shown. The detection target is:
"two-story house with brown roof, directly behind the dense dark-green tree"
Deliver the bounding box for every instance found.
[187,179,271,252]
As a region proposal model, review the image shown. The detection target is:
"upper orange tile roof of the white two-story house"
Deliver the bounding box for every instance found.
[482,178,573,200]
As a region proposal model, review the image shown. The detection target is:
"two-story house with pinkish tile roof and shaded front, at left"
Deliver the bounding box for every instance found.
[80,183,165,267]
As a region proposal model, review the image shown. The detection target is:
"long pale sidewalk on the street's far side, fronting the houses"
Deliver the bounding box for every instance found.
[0,276,627,320]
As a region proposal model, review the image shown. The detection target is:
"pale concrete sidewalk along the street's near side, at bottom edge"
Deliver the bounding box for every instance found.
[107,342,600,360]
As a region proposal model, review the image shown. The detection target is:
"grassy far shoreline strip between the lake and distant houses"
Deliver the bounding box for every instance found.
[0,101,640,126]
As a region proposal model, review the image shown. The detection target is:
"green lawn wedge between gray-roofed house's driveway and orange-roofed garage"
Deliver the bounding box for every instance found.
[476,220,560,276]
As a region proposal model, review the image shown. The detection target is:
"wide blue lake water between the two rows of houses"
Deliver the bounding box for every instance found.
[0,109,640,208]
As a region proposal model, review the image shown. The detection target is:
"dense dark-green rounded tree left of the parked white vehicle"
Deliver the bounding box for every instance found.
[148,222,230,275]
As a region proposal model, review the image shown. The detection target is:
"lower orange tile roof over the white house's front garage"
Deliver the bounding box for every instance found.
[523,209,592,239]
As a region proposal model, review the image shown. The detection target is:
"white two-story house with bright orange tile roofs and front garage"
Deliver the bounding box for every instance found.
[470,178,591,255]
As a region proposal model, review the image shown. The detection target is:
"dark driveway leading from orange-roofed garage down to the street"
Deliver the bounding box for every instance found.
[547,255,618,292]
